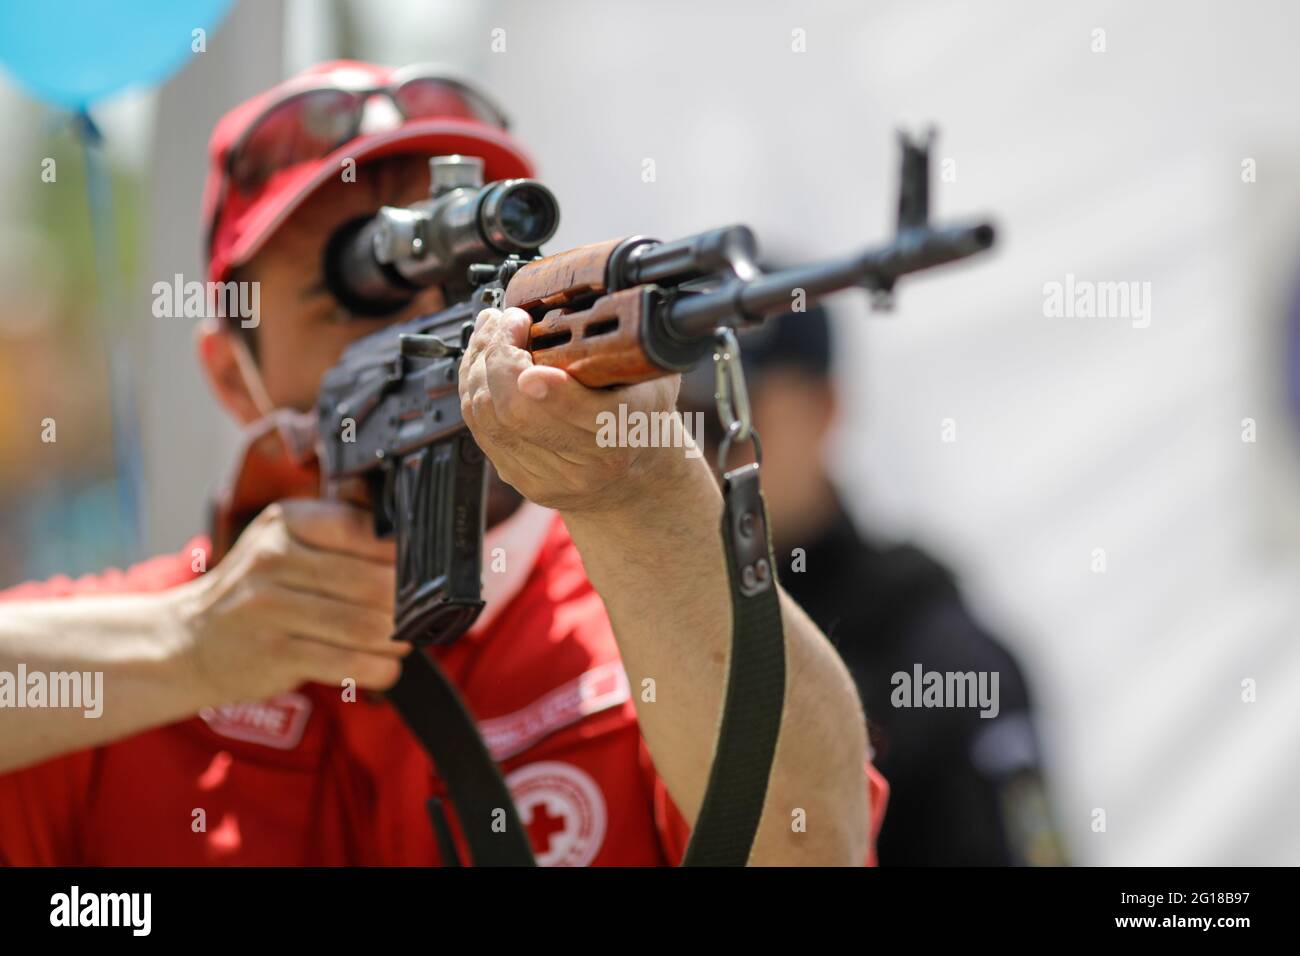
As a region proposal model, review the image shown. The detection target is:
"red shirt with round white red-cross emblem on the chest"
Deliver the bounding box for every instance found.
[0,518,887,866]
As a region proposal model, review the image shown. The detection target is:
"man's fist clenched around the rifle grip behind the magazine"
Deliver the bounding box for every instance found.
[169,499,411,702]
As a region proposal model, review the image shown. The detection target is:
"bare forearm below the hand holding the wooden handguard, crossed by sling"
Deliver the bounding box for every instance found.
[564,449,868,864]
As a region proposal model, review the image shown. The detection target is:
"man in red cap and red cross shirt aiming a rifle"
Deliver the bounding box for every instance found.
[0,62,982,865]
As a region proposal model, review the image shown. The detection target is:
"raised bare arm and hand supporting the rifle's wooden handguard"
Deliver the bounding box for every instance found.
[460,310,868,865]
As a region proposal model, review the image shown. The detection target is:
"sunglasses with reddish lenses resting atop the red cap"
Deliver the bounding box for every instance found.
[226,66,510,193]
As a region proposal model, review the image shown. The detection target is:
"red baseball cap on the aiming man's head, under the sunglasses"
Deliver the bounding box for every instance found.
[203,60,533,282]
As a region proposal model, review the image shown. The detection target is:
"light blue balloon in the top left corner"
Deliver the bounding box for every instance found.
[0,0,230,109]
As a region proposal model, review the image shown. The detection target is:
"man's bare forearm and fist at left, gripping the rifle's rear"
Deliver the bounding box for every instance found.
[0,501,411,773]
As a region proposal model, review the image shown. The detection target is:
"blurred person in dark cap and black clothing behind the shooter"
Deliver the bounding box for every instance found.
[679,307,1062,866]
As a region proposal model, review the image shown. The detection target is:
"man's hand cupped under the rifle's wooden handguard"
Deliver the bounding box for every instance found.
[460,308,681,515]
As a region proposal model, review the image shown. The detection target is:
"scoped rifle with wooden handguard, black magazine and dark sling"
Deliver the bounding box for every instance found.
[213,135,993,862]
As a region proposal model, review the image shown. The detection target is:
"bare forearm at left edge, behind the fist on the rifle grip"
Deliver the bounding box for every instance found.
[0,594,211,773]
